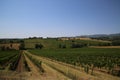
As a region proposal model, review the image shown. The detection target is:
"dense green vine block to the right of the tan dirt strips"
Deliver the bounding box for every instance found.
[29,48,120,77]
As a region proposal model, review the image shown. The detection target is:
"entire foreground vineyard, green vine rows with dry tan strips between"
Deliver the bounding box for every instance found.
[0,48,120,80]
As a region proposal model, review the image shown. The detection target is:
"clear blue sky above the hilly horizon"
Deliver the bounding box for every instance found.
[0,0,120,38]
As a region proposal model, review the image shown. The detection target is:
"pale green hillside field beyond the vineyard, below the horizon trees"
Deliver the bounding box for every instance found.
[24,38,111,49]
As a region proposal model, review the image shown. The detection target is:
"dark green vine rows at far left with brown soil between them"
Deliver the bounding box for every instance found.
[0,50,30,80]
